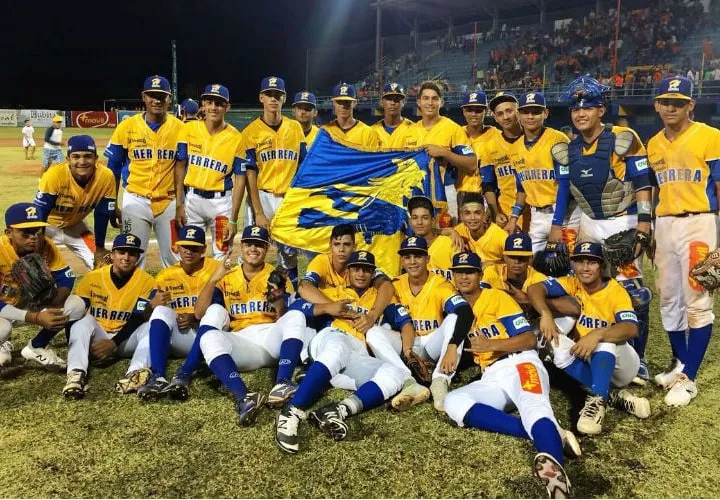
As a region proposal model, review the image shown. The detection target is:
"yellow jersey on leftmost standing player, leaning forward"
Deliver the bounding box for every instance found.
[34,161,116,229]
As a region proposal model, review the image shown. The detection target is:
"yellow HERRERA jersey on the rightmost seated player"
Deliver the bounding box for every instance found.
[542,276,637,337]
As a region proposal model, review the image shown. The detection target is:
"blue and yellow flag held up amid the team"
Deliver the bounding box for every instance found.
[271,130,430,276]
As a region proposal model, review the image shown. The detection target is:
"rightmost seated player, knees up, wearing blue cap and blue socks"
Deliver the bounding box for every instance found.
[527,242,650,435]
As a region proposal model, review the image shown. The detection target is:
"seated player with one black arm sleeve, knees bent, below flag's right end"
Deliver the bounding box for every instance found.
[367,236,472,411]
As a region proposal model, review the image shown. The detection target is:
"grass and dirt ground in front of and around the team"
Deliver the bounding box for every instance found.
[0,128,720,498]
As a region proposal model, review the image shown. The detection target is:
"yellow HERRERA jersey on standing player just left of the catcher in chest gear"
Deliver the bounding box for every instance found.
[510,128,569,207]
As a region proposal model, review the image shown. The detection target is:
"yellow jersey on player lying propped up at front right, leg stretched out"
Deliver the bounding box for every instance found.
[468,289,530,369]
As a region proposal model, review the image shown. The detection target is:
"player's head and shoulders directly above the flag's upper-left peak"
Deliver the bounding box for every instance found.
[322,83,380,150]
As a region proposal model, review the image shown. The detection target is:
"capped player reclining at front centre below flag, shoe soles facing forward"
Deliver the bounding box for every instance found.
[275,251,413,454]
